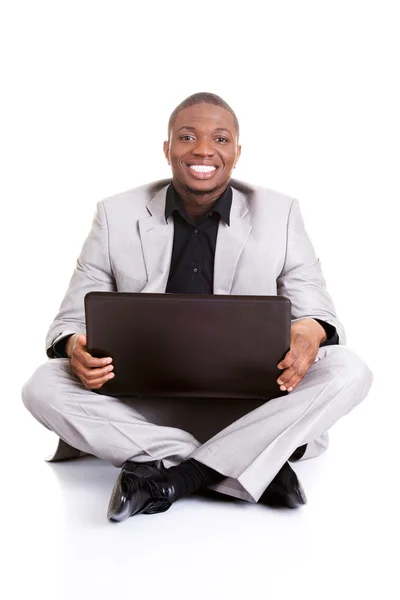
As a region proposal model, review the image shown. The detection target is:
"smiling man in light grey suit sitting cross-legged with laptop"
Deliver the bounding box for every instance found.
[22,93,372,521]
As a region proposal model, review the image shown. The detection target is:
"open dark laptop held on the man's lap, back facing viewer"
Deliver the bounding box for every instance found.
[85,292,291,400]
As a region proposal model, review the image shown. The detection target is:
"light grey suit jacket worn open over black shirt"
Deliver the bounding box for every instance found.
[46,179,345,357]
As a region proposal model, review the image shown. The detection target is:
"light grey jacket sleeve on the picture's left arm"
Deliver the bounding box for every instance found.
[46,202,116,358]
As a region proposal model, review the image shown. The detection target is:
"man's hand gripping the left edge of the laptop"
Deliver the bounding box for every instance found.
[65,333,114,390]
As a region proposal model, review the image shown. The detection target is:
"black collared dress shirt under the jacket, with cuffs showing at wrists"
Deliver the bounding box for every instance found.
[53,183,339,358]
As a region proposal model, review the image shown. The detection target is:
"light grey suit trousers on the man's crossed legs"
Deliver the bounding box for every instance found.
[22,345,373,502]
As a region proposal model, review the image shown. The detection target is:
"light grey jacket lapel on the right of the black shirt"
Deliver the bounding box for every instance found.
[214,188,252,294]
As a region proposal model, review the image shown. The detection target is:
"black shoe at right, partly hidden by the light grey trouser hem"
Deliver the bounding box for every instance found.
[259,462,307,508]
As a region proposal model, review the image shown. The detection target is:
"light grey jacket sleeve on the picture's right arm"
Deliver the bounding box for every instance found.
[277,200,346,345]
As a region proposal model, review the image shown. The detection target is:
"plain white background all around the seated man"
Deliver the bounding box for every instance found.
[0,0,400,599]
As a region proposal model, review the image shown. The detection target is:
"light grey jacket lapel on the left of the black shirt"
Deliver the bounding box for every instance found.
[139,186,174,293]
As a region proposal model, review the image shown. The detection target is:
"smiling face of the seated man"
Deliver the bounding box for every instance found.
[164,103,241,195]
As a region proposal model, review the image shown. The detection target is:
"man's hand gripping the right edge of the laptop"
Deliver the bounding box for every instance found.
[277,319,326,392]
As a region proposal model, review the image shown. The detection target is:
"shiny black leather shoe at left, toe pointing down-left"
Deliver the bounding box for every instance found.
[107,461,175,521]
